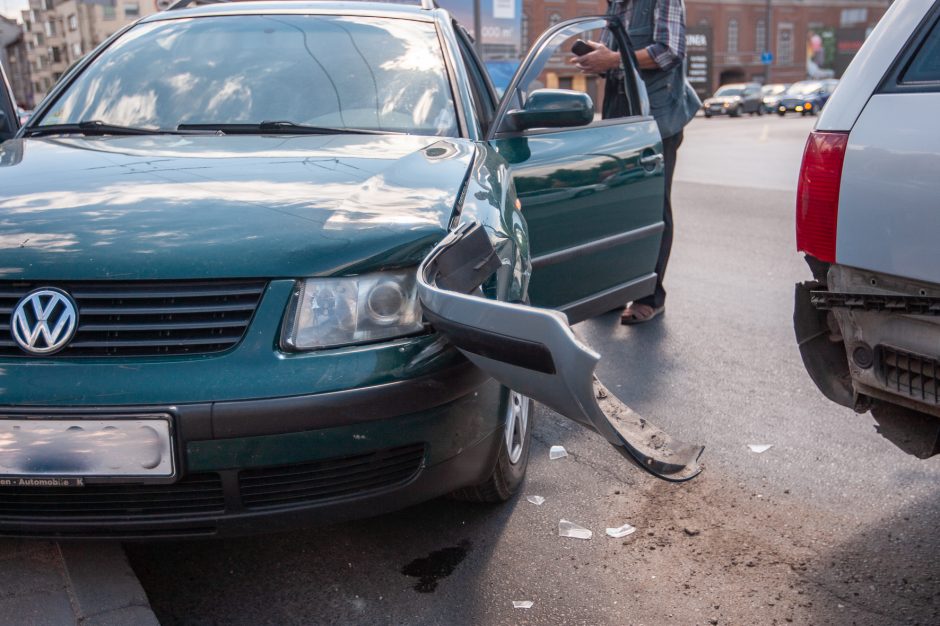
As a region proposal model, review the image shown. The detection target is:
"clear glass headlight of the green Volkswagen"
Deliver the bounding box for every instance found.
[281,268,424,351]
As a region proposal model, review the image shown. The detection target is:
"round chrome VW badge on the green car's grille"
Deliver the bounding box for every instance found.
[10,288,78,354]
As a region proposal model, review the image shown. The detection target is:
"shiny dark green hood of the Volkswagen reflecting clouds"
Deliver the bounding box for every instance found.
[0,135,473,280]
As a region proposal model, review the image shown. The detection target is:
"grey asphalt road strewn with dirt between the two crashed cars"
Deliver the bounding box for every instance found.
[128,117,940,624]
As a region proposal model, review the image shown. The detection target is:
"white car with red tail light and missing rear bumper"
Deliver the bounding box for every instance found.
[794,0,940,457]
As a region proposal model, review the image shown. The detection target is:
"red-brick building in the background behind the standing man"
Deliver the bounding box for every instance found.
[522,0,890,93]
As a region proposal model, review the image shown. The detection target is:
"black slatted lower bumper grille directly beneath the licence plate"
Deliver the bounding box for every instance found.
[0,474,225,520]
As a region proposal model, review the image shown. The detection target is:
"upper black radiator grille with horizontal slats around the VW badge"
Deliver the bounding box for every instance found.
[0,281,265,358]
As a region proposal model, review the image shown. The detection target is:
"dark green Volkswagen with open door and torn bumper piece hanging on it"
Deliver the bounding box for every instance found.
[0,2,700,538]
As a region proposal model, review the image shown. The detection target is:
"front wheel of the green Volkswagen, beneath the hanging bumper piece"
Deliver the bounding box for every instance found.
[451,388,535,503]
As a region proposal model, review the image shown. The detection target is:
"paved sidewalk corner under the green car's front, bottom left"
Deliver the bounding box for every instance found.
[0,539,159,626]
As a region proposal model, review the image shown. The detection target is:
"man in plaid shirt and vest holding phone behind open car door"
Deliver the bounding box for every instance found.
[573,0,702,324]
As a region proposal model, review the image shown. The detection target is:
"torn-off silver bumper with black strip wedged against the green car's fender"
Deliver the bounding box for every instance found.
[418,224,704,482]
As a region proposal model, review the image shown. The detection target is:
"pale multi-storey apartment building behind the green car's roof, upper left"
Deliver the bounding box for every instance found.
[23,0,162,102]
